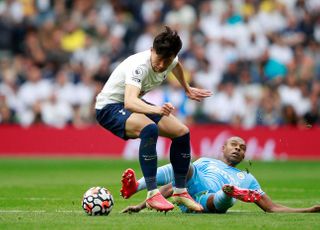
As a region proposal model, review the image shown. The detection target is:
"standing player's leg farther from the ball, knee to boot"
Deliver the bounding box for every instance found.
[158,115,203,211]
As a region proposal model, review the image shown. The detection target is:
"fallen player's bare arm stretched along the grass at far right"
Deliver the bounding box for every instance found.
[255,194,320,213]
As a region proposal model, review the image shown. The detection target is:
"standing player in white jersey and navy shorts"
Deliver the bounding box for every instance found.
[95,27,212,212]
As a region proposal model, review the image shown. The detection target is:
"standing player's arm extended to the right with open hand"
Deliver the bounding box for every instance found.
[172,62,212,101]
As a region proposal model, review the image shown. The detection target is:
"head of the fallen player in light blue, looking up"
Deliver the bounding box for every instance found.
[222,137,247,165]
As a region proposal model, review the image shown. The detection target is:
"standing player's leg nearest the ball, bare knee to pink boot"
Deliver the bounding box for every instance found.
[125,113,173,211]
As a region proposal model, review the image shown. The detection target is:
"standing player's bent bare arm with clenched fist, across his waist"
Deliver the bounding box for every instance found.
[124,84,174,116]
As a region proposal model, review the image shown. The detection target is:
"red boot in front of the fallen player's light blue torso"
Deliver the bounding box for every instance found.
[222,184,261,203]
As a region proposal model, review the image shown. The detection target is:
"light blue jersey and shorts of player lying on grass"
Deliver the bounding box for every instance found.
[185,158,264,212]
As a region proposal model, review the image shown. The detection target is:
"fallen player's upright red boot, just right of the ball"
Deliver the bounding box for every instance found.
[120,168,139,199]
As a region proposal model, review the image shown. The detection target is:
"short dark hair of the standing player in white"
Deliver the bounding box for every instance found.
[153,26,182,58]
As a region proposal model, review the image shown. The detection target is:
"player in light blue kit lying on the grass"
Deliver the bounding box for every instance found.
[121,137,320,213]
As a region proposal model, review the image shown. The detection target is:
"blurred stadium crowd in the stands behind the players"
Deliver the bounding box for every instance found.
[0,0,320,128]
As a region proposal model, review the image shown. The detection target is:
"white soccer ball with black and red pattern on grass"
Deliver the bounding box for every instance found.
[82,187,114,216]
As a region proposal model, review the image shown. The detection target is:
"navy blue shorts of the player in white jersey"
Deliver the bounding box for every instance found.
[96,102,162,140]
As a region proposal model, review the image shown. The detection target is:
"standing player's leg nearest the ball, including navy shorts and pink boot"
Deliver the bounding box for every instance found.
[96,103,174,211]
